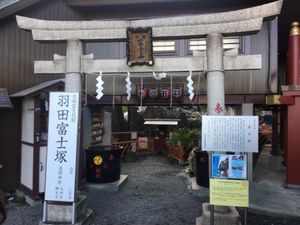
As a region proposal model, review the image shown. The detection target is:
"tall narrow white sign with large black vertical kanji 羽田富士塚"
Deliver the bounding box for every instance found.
[45,92,79,202]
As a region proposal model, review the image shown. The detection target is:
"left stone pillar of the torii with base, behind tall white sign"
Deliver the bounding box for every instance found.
[45,40,92,225]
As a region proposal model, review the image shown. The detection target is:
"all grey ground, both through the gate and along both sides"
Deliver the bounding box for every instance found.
[4,152,300,225]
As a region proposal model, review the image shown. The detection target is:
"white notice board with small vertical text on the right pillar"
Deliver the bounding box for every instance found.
[202,116,258,152]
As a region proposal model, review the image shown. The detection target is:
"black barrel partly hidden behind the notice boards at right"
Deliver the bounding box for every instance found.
[195,150,209,187]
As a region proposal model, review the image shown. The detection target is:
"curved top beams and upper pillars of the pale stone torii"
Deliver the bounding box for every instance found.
[17,0,283,223]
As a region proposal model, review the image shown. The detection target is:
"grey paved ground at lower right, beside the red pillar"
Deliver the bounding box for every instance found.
[250,146,300,216]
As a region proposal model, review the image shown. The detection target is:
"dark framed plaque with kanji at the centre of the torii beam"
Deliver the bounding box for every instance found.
[127,27,154,66]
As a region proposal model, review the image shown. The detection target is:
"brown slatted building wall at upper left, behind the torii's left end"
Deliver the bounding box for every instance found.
[0,0,81,94]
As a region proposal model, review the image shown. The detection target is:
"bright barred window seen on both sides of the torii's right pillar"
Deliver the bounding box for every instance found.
[188,37,240,52]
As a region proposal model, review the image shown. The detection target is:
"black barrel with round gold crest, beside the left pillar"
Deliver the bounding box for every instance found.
[85,146,121,183]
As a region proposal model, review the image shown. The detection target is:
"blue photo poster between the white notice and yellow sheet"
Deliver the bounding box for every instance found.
[212,154,247,179]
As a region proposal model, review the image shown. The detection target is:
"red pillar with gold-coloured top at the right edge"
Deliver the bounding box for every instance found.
[280,22,300,188]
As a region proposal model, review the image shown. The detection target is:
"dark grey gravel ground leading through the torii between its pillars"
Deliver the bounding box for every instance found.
[4,156,207,225]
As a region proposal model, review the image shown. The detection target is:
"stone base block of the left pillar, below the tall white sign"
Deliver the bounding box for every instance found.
[46,195,87,223]
